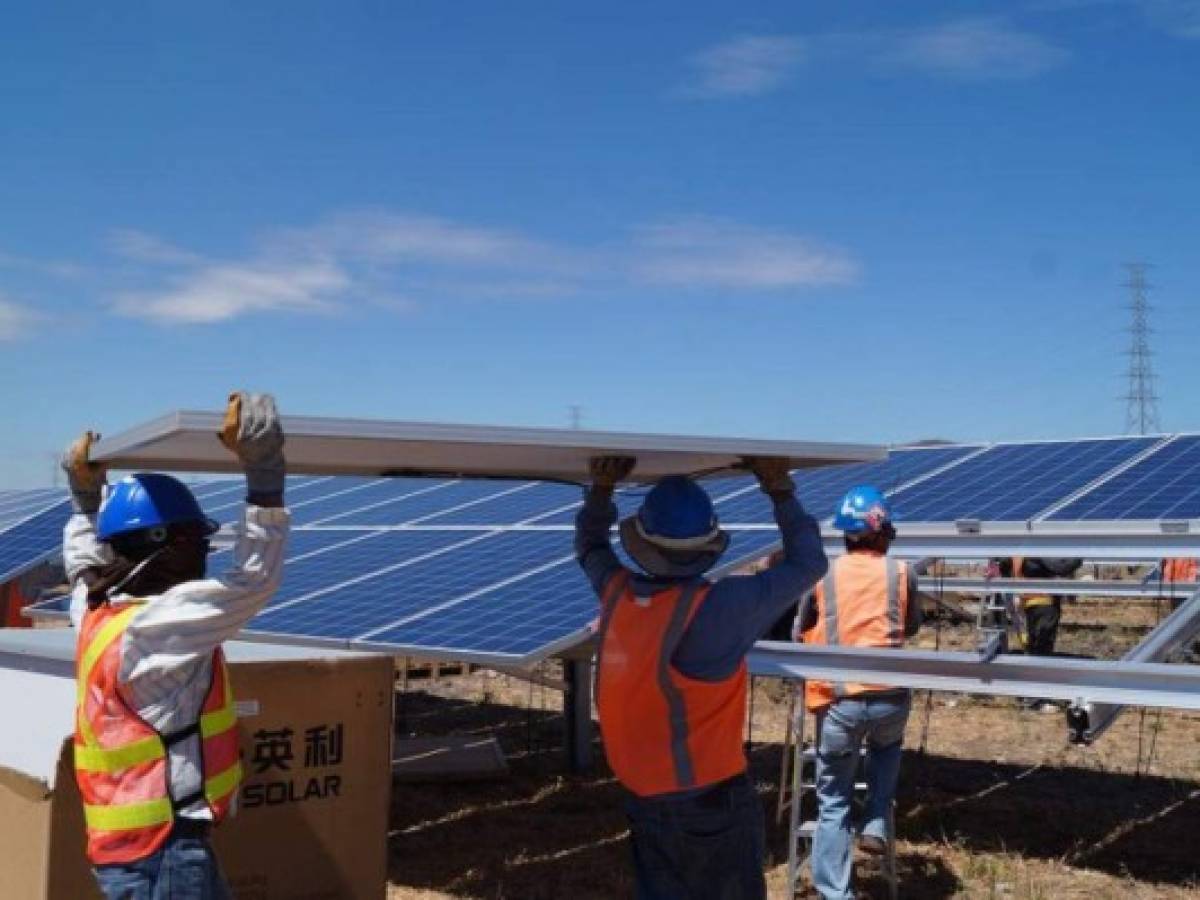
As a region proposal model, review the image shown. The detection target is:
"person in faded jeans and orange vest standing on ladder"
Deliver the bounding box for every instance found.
[797,485,920,900]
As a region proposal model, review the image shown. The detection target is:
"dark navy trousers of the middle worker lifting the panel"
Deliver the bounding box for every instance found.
[625,775,767,900]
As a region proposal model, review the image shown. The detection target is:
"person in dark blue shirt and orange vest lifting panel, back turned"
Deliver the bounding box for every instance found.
[575,457,827,900]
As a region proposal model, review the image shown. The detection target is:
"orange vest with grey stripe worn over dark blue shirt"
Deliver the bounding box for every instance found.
[596,571,746,797]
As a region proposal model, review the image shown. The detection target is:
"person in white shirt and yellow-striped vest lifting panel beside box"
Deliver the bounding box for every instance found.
[64,394,288,900]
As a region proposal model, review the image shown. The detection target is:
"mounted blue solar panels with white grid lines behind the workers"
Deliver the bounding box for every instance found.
[7,436,1200,662]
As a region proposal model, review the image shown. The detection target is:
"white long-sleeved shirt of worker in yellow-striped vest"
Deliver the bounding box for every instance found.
[62,505,290,818]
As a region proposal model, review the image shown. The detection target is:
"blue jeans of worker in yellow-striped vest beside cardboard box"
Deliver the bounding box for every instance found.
[92,833,233,900]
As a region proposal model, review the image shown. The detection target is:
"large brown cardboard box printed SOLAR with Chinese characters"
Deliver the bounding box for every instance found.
[0,630,394,900]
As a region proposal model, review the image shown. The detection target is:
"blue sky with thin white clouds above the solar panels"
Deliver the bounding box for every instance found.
[0,0,1200,486]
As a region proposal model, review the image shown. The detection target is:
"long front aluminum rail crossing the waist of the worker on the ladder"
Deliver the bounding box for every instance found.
[749,641,1200,710]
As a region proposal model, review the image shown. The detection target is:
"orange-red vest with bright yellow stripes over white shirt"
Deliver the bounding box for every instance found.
[74,604,241,865]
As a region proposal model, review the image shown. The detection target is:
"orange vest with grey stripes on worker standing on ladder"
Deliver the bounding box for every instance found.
[803,552,908,713]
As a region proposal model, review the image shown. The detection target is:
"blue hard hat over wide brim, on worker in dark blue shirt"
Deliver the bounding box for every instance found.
[620,475,730,577]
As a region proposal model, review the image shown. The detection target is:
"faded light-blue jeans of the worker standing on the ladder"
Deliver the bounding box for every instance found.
[812,691,912,900]
